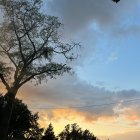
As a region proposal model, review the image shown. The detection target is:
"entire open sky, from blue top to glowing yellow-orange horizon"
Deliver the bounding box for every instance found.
[0,0,140,140]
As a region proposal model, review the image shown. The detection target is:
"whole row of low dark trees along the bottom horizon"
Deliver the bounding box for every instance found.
[0,95,107,140]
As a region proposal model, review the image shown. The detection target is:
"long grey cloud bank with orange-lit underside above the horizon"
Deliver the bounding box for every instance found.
[20,75,140,122]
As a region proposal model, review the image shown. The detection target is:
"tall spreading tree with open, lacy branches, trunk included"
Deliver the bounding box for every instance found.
[0,0,79,140]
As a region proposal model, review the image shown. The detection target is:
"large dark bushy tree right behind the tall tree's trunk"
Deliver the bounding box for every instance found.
[0,95,43,140]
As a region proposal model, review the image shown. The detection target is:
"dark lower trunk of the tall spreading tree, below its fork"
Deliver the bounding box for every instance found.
[0,91,16,140]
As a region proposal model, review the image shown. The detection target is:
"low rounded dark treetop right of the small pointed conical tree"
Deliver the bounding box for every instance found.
[58,123,97,140]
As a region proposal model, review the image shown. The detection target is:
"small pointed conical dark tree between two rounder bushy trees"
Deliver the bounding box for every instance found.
[41,124,58,140]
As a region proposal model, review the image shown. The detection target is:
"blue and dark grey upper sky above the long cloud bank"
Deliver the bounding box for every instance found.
[43,0,140,90]
